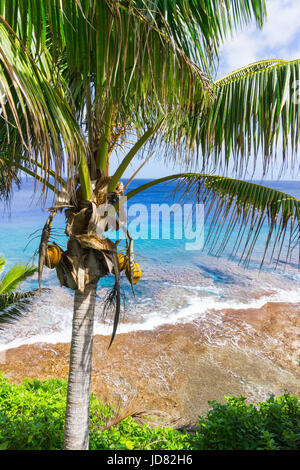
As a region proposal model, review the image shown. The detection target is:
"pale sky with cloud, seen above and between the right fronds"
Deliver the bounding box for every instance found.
[111,0,300,180]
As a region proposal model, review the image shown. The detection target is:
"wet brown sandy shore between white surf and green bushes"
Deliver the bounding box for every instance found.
[0,303,300,424]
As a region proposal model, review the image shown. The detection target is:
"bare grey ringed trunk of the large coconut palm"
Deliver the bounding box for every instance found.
[64,282,97,450]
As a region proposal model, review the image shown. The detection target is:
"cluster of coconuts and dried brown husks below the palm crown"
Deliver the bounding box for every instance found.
[39,176,141,291]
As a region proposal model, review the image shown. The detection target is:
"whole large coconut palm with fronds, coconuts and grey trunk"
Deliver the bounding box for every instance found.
[0,0,299,449]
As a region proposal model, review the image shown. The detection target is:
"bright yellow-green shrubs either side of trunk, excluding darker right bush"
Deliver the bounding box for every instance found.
[0,375,190,450]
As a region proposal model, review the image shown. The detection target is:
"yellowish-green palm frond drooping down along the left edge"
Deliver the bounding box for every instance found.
[0,17,85,198]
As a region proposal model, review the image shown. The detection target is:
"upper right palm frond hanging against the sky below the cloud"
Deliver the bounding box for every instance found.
[198,60,300,172]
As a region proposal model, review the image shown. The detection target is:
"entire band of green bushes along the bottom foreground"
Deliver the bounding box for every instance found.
[0,376,300,450]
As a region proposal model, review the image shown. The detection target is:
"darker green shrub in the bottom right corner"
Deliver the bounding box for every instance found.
[193,393,300,450]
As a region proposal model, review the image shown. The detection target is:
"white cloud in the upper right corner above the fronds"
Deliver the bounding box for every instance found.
[218,0,300,76]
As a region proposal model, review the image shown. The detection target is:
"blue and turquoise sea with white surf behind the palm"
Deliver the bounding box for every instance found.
[0,180,300,350]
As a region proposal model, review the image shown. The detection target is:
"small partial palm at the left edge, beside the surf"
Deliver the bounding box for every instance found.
[0,256,37,327]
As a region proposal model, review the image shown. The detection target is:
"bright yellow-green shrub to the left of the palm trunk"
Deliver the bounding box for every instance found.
[0,376,66,450]
